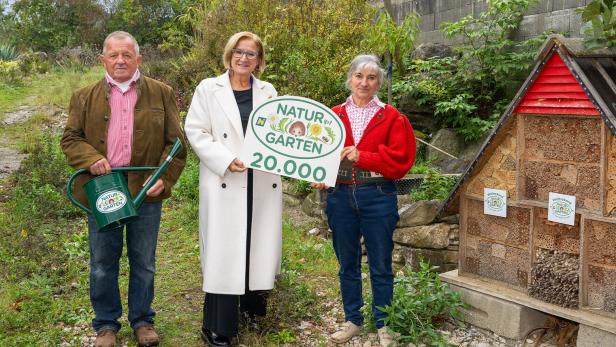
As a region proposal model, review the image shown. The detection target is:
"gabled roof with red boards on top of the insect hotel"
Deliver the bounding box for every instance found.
[441,35,616,213]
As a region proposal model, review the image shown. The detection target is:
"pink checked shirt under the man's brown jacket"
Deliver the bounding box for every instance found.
[105,70,141,167]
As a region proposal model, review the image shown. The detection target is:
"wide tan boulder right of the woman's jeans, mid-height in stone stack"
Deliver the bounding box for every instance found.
[393,223,451,249]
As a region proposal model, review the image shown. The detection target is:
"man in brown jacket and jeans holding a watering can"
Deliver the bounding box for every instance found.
[61,31,186,347]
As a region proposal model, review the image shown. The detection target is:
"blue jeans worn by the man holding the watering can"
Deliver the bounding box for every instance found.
[88,202,162,331]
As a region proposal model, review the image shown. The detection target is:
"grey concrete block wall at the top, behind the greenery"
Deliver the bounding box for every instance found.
[381,0,591,43]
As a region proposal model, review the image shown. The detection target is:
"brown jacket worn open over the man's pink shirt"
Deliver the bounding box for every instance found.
[60,75,187,205]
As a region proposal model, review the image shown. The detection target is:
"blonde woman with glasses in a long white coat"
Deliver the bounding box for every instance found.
[185,32,282,346]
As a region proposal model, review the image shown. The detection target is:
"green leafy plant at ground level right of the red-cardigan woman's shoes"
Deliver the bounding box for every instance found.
[380,260,465,346]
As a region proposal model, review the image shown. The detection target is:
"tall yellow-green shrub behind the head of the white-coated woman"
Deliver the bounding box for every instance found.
[183,0,376,105]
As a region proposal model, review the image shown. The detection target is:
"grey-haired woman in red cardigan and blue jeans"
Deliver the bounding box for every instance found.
[314,55,415,346]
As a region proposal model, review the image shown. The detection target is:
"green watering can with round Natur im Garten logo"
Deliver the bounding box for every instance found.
[66,138,182,231]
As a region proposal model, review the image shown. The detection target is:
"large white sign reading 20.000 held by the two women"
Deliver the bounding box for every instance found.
[240,96,345,186]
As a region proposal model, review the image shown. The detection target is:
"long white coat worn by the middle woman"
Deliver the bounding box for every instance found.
[185,72,282,294]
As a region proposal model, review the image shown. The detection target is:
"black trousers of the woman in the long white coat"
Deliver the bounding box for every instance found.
[202,169,267,337]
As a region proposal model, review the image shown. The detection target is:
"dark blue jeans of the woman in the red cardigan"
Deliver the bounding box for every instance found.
[326,181,399,328]
